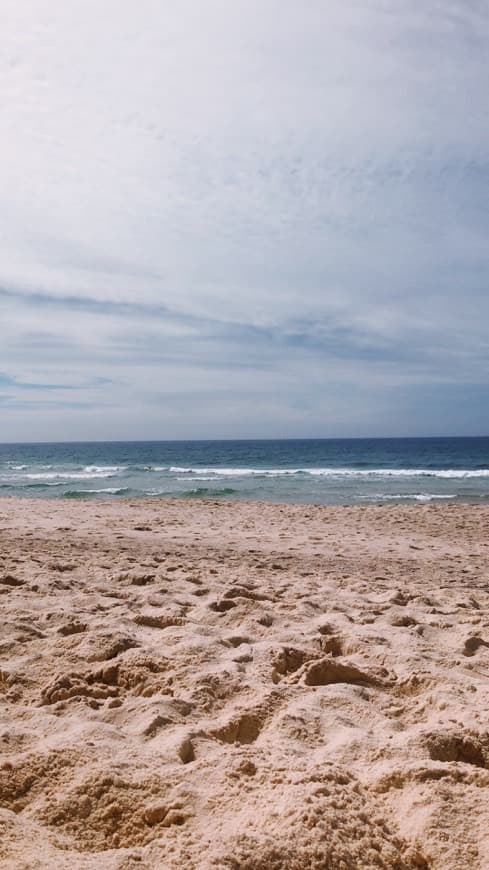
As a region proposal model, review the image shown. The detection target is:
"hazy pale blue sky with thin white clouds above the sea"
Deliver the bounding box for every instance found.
[0,0,489,441]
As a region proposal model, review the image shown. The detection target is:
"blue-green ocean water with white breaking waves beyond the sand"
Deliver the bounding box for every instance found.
[0,438,489,504]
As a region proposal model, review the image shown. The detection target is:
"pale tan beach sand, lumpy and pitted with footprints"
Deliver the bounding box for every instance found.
[0,499,489,870]
